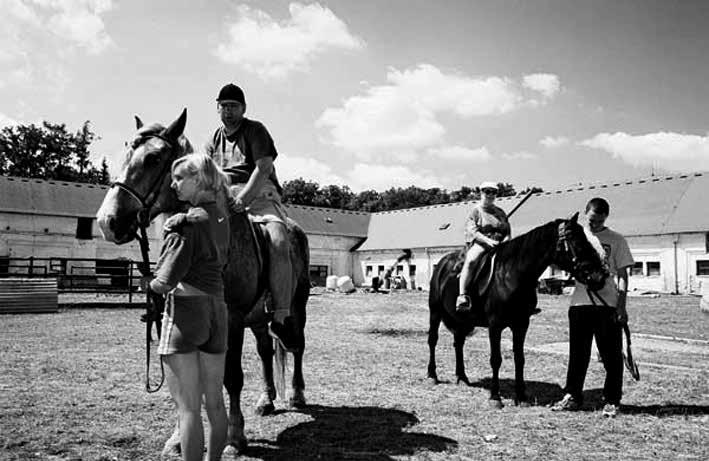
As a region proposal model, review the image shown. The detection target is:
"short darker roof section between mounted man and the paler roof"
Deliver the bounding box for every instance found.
[285,205,370,238]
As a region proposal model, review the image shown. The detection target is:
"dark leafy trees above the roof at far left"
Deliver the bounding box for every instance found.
[0,121,110,184]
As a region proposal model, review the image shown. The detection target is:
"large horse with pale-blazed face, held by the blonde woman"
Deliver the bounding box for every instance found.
[97,111,310,452]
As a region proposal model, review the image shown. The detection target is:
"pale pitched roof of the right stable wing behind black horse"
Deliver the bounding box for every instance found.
[359,173,709,251]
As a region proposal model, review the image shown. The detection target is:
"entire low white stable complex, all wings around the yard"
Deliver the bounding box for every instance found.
[0,173,709,293]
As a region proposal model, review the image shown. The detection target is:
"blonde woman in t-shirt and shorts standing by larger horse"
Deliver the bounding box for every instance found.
[146,154,230,461]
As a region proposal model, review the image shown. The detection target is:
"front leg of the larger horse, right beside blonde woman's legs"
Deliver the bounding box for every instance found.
[224,314,247,459]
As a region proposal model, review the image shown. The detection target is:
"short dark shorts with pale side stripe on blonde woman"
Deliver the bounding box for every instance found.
[158,291,229,355]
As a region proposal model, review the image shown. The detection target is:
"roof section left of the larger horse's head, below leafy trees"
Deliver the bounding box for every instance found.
[0,176,108,218]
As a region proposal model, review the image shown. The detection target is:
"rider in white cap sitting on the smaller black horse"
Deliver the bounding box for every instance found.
[455,181,511,313]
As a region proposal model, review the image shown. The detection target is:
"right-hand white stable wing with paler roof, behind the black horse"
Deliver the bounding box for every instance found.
[355,173,709,293]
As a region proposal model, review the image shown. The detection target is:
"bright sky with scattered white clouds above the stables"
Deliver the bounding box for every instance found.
[0,0,709,191]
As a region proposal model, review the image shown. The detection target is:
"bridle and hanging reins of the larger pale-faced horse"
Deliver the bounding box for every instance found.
[111,134,177,394]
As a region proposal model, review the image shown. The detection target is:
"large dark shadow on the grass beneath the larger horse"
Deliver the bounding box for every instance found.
[245,405,458,460]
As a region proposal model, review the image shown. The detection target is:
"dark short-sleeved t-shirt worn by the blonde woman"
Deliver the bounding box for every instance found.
[155,202,229,296]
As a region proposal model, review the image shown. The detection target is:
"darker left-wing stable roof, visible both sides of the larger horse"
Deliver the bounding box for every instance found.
[0,176,370,238]
